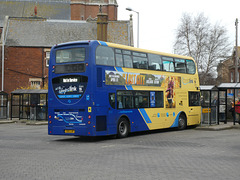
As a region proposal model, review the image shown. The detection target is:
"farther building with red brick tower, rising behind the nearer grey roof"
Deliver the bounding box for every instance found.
[0,0,118,29]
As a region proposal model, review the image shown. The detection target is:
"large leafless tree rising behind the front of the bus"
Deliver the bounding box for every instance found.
[174,13,230,84]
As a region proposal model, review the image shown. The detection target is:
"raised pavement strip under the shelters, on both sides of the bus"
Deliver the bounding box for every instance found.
[0,119,240,131]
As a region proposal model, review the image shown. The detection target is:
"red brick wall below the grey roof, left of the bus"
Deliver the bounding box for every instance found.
[0,47,48,94]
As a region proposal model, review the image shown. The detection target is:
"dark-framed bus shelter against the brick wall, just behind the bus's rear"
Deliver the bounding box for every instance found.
[11,89,48,120]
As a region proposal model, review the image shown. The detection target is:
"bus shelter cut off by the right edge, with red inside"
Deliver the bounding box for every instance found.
[218,83,240,125]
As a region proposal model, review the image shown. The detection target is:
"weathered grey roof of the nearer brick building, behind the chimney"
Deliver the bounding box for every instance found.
[0,17,131,48]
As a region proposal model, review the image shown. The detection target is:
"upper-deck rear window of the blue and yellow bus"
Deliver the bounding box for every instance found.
[56,47,85,63]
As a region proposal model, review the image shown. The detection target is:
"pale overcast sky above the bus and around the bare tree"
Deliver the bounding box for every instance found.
[117,0,240,53]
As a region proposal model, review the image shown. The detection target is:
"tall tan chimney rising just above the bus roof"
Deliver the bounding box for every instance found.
[97,5,108,41]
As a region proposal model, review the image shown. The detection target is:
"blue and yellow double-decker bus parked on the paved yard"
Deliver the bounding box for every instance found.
[48,40,201,138]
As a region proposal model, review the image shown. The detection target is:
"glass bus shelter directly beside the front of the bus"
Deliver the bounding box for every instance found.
[200,85,221,125]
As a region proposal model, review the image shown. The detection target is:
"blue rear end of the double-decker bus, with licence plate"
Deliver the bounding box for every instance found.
[48,41,99,136]
